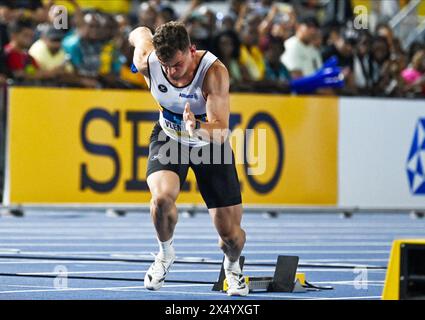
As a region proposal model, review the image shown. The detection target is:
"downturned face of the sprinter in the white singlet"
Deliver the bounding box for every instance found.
[160,46,196,81]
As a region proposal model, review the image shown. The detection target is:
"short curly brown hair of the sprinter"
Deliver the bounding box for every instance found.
[153,21,190,61]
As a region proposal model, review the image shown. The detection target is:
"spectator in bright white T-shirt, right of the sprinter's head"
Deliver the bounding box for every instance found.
[281,17,323,79]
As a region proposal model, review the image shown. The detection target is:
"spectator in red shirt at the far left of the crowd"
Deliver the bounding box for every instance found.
[5,19,58,82]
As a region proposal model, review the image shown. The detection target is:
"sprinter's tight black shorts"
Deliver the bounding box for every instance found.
[146,123,242,209]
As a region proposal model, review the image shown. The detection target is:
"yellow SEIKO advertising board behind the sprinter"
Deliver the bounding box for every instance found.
[5,88,338,205]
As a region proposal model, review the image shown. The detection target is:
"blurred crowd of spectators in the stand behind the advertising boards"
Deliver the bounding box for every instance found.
[0,0,425,97]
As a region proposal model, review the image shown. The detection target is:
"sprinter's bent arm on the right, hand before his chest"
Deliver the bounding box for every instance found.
[198,60,230,144]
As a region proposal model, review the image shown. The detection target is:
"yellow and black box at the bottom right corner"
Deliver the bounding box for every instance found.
[382,239,425,300]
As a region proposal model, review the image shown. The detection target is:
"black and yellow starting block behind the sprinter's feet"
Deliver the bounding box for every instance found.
[212,256,319,293]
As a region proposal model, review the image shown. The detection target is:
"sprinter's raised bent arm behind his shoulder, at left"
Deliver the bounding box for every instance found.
[128,27,154,77]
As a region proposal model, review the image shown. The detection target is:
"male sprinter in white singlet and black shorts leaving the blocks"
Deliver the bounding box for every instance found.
[129,22,249,296]
